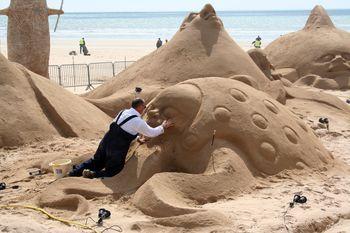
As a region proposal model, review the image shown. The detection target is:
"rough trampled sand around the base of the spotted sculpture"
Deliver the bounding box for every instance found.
[0,88,350,233]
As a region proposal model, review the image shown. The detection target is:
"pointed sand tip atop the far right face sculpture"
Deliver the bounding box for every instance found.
[304,5,335,30]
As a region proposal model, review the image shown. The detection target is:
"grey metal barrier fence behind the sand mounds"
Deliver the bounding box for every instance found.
[49,61,134,89]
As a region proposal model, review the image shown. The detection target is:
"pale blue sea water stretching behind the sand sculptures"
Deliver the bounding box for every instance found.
[0,10,350,42]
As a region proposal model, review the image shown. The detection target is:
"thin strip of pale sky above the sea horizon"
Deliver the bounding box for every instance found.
[0,0,350,12]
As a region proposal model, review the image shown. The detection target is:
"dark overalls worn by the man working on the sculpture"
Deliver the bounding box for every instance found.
[69,111,137,178]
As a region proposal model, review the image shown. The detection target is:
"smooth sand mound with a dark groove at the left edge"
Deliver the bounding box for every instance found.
[0,55,110,147]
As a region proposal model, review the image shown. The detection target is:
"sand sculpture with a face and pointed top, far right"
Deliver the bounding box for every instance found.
[265,6,350,89]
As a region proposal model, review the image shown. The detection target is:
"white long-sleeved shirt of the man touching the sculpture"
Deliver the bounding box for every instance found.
[113,108,164,138]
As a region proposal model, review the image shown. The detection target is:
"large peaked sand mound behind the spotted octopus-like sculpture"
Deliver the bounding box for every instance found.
[85,4,285,116]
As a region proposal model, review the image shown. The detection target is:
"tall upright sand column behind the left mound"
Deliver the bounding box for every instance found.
[0,0,63,77]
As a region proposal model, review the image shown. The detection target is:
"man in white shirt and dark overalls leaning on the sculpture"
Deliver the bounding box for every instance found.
[69,98,173,178]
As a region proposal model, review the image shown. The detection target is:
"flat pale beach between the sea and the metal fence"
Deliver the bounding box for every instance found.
[1,38,252,65]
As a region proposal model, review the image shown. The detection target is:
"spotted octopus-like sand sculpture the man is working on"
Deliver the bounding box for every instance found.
[37,77,333,225]
